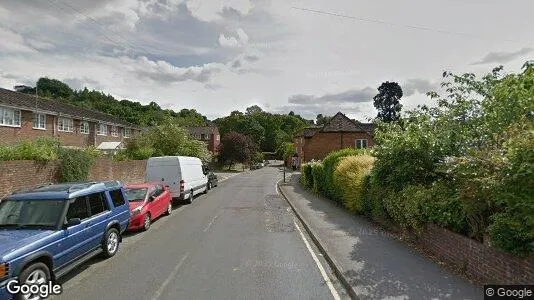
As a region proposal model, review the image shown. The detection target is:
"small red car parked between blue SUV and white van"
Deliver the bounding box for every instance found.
[126,182,172,230]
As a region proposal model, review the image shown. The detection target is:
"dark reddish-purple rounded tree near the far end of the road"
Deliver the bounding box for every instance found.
[219,131,258,169]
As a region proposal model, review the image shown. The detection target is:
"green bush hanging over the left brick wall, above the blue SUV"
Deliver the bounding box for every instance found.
[59,149,95,182]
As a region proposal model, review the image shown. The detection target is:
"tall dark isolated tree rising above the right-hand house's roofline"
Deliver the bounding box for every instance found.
[373,81,402,122]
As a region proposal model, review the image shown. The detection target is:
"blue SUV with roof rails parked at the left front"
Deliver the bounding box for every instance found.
[0,181,130,299]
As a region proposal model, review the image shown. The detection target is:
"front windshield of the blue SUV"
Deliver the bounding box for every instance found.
[0,200,65,228]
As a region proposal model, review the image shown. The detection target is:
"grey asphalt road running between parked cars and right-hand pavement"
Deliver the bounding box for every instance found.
[53,166,347,300]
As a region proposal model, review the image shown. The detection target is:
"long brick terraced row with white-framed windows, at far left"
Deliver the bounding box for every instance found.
[0,88,141,148]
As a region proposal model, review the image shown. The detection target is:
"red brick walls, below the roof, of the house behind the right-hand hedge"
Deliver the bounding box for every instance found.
[303,132,374,162]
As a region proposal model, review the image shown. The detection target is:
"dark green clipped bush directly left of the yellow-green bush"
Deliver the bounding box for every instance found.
[321,148,365,203]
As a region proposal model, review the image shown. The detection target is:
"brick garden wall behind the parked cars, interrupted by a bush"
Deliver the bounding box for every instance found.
[0,158,146,199]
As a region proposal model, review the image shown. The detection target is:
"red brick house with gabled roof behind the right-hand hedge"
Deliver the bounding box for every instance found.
[294,112,375,163]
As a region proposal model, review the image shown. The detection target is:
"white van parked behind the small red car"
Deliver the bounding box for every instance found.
[146,156,208,203]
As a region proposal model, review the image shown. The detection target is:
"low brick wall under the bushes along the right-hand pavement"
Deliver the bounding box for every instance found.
[418,225,534,284]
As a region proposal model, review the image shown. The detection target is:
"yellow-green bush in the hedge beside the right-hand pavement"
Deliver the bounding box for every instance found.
[333,155,374,213]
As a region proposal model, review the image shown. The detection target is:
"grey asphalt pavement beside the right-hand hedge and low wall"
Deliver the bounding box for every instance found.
[279,172,484,299]
